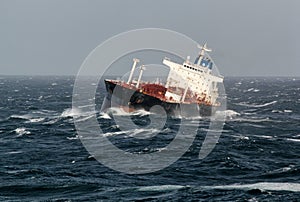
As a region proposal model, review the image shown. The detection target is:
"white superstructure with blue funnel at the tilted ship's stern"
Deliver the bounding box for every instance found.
[163,44,223,105]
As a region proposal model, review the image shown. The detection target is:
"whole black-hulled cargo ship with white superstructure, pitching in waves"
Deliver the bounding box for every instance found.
[102,43,223,116]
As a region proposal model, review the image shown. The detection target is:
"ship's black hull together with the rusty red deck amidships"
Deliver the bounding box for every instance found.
[102,80,213,117]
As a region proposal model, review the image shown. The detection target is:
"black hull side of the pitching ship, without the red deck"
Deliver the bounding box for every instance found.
[101,80,213,117]
